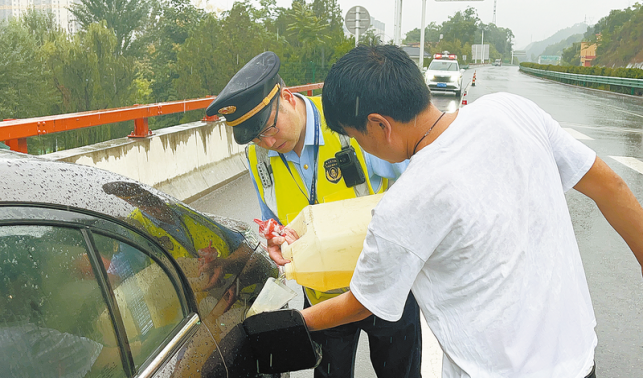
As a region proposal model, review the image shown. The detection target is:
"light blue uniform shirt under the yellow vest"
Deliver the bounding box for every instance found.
[248,93,409,221]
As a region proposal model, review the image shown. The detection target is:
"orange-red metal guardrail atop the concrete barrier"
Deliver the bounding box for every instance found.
[0,83,324,153]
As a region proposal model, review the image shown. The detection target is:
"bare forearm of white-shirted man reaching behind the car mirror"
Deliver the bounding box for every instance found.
[301,291,372,331]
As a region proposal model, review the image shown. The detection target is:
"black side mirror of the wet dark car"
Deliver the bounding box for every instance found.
[243,309,321,374]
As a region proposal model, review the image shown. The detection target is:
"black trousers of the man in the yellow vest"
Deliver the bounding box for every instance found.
[304,293,422,378]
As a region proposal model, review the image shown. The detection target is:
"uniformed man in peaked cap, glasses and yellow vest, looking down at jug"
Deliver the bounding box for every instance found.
[206,51,421,377]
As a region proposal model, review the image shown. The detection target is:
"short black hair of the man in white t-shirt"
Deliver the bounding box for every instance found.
[322,45,431,134]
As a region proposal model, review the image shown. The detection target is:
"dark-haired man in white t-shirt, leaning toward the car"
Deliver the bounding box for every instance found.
[296,46,643,378]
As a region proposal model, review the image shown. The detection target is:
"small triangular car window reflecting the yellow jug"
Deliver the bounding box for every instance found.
[94,234,185,369]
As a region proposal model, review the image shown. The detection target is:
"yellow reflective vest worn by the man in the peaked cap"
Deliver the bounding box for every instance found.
[247,97,388,305]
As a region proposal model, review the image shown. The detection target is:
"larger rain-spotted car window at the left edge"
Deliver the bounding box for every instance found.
[0,226,126,378]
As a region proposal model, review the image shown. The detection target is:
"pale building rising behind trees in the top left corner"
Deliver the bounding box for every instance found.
[0,0,78,33]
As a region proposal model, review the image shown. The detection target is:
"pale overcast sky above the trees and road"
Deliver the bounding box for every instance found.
[204,0,636,50]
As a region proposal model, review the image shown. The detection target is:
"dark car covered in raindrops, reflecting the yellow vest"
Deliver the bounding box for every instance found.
[0,151,316,377]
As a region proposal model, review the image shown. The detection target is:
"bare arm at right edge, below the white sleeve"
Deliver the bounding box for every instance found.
[574,157,643,274]
